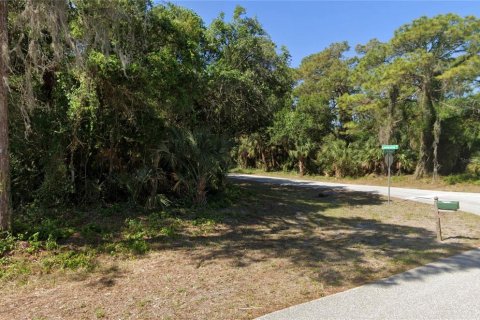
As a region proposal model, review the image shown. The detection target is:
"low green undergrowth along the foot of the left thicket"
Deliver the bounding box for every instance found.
[0,185,250,281]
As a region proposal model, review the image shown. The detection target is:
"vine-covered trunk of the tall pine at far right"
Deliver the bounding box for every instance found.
[414,84,436,179]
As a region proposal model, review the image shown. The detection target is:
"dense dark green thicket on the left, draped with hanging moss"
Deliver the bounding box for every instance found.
[10,0,284,212]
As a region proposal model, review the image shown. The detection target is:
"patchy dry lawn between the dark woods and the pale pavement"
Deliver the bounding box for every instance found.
[0,181,480,319]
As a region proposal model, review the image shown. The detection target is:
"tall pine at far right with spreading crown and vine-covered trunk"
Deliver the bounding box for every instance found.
[389,14,480,177]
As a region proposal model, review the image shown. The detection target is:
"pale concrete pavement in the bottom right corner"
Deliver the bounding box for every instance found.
[258,249,480,320]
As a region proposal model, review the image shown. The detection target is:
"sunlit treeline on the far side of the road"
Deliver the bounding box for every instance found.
[235,14,480,178]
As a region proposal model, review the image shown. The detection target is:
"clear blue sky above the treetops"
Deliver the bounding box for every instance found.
[166,0,480,67]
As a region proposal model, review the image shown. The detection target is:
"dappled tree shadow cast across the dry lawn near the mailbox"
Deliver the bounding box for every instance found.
[147,179,471,285]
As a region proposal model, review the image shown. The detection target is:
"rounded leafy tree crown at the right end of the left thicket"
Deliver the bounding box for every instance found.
[203,6,293,136]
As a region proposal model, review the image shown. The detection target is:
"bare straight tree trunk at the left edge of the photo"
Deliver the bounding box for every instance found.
[0,1,11,231]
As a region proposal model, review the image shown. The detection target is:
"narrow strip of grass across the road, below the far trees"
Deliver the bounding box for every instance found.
[231,168,480,192]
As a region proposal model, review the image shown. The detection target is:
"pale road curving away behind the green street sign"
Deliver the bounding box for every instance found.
[230,174,480,216]
